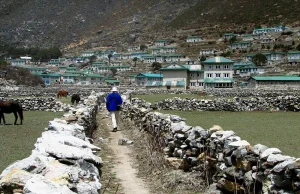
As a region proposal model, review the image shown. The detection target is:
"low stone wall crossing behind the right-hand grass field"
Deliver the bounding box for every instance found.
[152,95,300,112]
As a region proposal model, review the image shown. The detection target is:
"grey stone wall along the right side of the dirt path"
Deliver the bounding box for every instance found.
[122,99,300,193]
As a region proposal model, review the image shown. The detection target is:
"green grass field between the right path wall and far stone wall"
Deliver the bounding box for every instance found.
[160,110,300,157]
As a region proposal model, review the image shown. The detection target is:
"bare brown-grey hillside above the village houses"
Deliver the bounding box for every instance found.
[0,0,300,49]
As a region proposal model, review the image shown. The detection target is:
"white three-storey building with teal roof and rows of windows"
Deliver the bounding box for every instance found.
[201,56,234,88]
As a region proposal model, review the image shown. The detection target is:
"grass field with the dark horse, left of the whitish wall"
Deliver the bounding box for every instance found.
[0,111,64,172]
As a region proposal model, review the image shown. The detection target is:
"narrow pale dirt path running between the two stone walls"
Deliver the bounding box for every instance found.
[101,112,150,194]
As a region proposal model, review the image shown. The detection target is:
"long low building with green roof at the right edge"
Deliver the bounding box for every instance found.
[248,76,300,89]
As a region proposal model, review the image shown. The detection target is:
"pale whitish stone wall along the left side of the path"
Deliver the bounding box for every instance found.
[0,92,104,194]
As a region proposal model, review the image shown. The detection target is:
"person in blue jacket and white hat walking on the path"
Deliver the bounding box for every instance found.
[106,87,123,132]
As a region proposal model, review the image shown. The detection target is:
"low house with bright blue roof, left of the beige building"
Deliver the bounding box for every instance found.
[135,73,163,86]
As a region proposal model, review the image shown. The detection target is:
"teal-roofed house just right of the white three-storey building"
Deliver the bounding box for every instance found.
[233,61,264,77]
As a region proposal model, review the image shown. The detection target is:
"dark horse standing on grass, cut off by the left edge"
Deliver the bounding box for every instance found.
[0,100,24,125]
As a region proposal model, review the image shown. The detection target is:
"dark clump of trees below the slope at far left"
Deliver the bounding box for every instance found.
[0,46,62,62]
